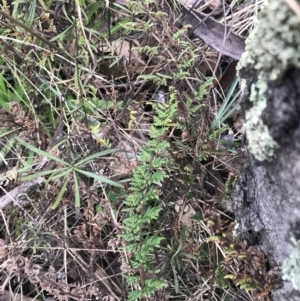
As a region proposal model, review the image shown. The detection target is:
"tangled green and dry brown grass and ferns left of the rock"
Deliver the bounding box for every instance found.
[0,0,269,300]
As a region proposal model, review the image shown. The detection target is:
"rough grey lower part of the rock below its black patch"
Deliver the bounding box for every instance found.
[232,132,300,301]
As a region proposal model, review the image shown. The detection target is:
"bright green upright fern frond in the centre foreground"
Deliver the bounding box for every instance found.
[122,92,178,301]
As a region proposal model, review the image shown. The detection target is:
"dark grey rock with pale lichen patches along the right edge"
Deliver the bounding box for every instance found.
[232,0,300,301]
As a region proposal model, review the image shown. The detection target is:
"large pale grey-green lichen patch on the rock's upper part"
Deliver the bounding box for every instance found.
[237,0,300,161]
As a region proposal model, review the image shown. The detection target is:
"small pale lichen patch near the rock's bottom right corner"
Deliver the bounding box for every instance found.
[282,238,300,291]
